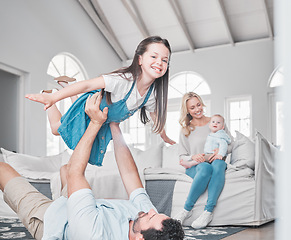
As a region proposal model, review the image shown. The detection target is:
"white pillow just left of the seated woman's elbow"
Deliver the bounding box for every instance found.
[162,144,185,173]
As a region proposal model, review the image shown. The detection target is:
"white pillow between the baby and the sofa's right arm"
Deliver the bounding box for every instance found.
[230,131,255,170]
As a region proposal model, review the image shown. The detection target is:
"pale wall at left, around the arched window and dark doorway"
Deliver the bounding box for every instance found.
[0,0,121,155]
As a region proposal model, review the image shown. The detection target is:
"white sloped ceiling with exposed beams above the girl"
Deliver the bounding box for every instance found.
[79,0,274,61]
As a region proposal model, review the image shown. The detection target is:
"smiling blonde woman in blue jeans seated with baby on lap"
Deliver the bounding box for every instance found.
[175,92,233,229]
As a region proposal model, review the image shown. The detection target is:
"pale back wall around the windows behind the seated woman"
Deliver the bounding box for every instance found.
[170,40,274,138]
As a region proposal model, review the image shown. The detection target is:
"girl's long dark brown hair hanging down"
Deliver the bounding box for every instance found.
[106,36,172,133]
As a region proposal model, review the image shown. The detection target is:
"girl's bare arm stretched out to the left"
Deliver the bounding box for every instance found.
[25,76,105,110]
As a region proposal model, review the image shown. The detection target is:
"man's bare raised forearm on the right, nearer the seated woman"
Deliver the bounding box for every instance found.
[110,123,143,196]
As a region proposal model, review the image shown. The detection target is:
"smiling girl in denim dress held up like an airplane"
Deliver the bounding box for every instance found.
[26,36,175,166]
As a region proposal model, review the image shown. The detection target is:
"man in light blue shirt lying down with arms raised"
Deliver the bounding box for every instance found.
[0,94,184,240]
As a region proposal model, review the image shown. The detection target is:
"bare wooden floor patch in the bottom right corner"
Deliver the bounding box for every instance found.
[223,222,275,240]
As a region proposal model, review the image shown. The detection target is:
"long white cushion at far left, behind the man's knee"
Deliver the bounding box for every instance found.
[1,148,70,179]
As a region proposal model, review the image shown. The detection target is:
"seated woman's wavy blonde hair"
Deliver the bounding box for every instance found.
[179,92,205,137]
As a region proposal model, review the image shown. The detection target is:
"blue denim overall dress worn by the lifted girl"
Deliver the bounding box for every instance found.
[58,81,153,166]
